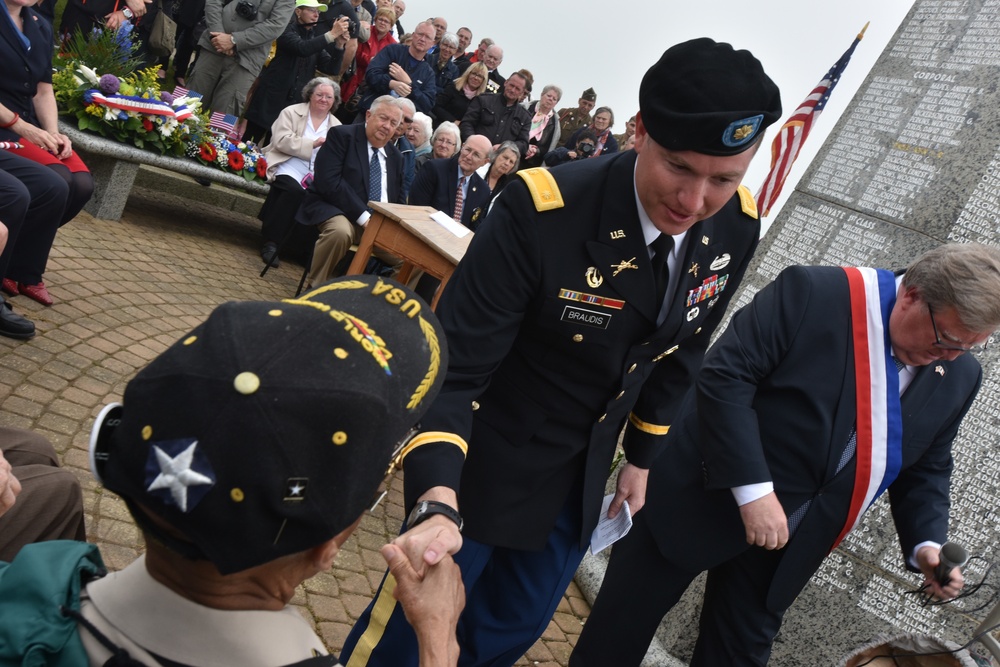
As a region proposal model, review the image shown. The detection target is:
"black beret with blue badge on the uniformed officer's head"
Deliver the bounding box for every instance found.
[639,37,781,155]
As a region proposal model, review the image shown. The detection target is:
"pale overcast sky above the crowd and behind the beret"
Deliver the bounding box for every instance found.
[410,0,913,221]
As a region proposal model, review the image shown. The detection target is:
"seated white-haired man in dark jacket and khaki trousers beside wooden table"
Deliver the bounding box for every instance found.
[296,95,403,287]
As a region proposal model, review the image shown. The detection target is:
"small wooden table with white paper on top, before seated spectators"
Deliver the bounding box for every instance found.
[347,202,473,308]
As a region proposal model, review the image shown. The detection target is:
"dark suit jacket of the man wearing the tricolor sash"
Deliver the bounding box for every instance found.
[643,267,982,611]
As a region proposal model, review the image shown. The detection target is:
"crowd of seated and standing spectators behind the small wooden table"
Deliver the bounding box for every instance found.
[243,0,635,286]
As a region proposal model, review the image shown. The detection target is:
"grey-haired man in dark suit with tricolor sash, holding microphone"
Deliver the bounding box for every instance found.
[570,244,1000,667]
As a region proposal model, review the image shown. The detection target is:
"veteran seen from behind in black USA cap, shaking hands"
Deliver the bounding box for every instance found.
[64,276,462,667]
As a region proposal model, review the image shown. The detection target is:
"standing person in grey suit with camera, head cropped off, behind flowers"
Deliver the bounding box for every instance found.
[188,0,295,116]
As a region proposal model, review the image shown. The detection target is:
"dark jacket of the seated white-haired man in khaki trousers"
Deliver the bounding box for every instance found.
[295,124,403,225]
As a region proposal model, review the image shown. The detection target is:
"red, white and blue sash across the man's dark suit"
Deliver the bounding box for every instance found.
[833,267,903,548]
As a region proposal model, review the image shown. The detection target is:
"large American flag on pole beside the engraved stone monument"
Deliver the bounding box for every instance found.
[757,23,868,216]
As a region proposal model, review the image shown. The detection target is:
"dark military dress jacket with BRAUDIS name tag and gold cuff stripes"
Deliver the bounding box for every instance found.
[405,153,760,550]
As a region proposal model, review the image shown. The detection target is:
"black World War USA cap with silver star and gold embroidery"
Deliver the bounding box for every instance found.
[91,275,447,574]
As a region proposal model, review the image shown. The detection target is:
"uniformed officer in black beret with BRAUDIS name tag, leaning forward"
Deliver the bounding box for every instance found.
[344,39,781,667]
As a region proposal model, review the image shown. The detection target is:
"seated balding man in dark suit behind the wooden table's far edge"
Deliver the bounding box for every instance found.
[410,134,490,231]
